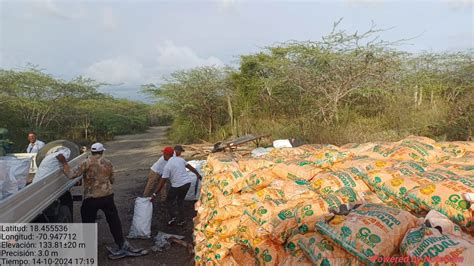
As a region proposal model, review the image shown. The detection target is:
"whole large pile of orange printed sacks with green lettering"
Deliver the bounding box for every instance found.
[194,137,474,265]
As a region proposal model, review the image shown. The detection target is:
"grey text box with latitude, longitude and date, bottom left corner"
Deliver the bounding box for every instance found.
[0,223,97,265]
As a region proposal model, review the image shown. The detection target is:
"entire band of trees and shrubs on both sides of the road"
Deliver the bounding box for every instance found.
[0,23,474,150]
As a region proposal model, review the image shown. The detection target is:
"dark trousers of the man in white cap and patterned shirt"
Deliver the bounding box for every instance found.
[81,194,124,248]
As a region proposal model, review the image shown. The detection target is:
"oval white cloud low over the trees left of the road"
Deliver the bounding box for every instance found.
[84,57,144,84]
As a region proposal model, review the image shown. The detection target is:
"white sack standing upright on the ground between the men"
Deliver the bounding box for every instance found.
[127,198,153,239]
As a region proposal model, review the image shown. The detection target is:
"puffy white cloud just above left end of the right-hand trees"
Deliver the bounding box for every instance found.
[157,41,224,69]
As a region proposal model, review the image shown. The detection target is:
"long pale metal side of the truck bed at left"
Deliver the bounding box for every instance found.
[0,153,88,223]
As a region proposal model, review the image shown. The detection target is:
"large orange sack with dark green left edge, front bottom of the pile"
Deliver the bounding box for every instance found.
[316,203,421,264]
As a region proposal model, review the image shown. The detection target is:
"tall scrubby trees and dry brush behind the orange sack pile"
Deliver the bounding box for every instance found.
[143,25,474,144]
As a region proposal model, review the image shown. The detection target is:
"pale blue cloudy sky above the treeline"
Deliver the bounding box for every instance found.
[0,0,474,101]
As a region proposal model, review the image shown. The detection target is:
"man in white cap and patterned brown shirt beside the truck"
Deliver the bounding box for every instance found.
[62,143,131,254]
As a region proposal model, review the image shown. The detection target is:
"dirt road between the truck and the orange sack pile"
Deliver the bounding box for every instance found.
[74,127,194,266]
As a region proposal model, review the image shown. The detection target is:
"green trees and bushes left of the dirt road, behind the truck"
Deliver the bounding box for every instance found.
[0,68,151,151]
